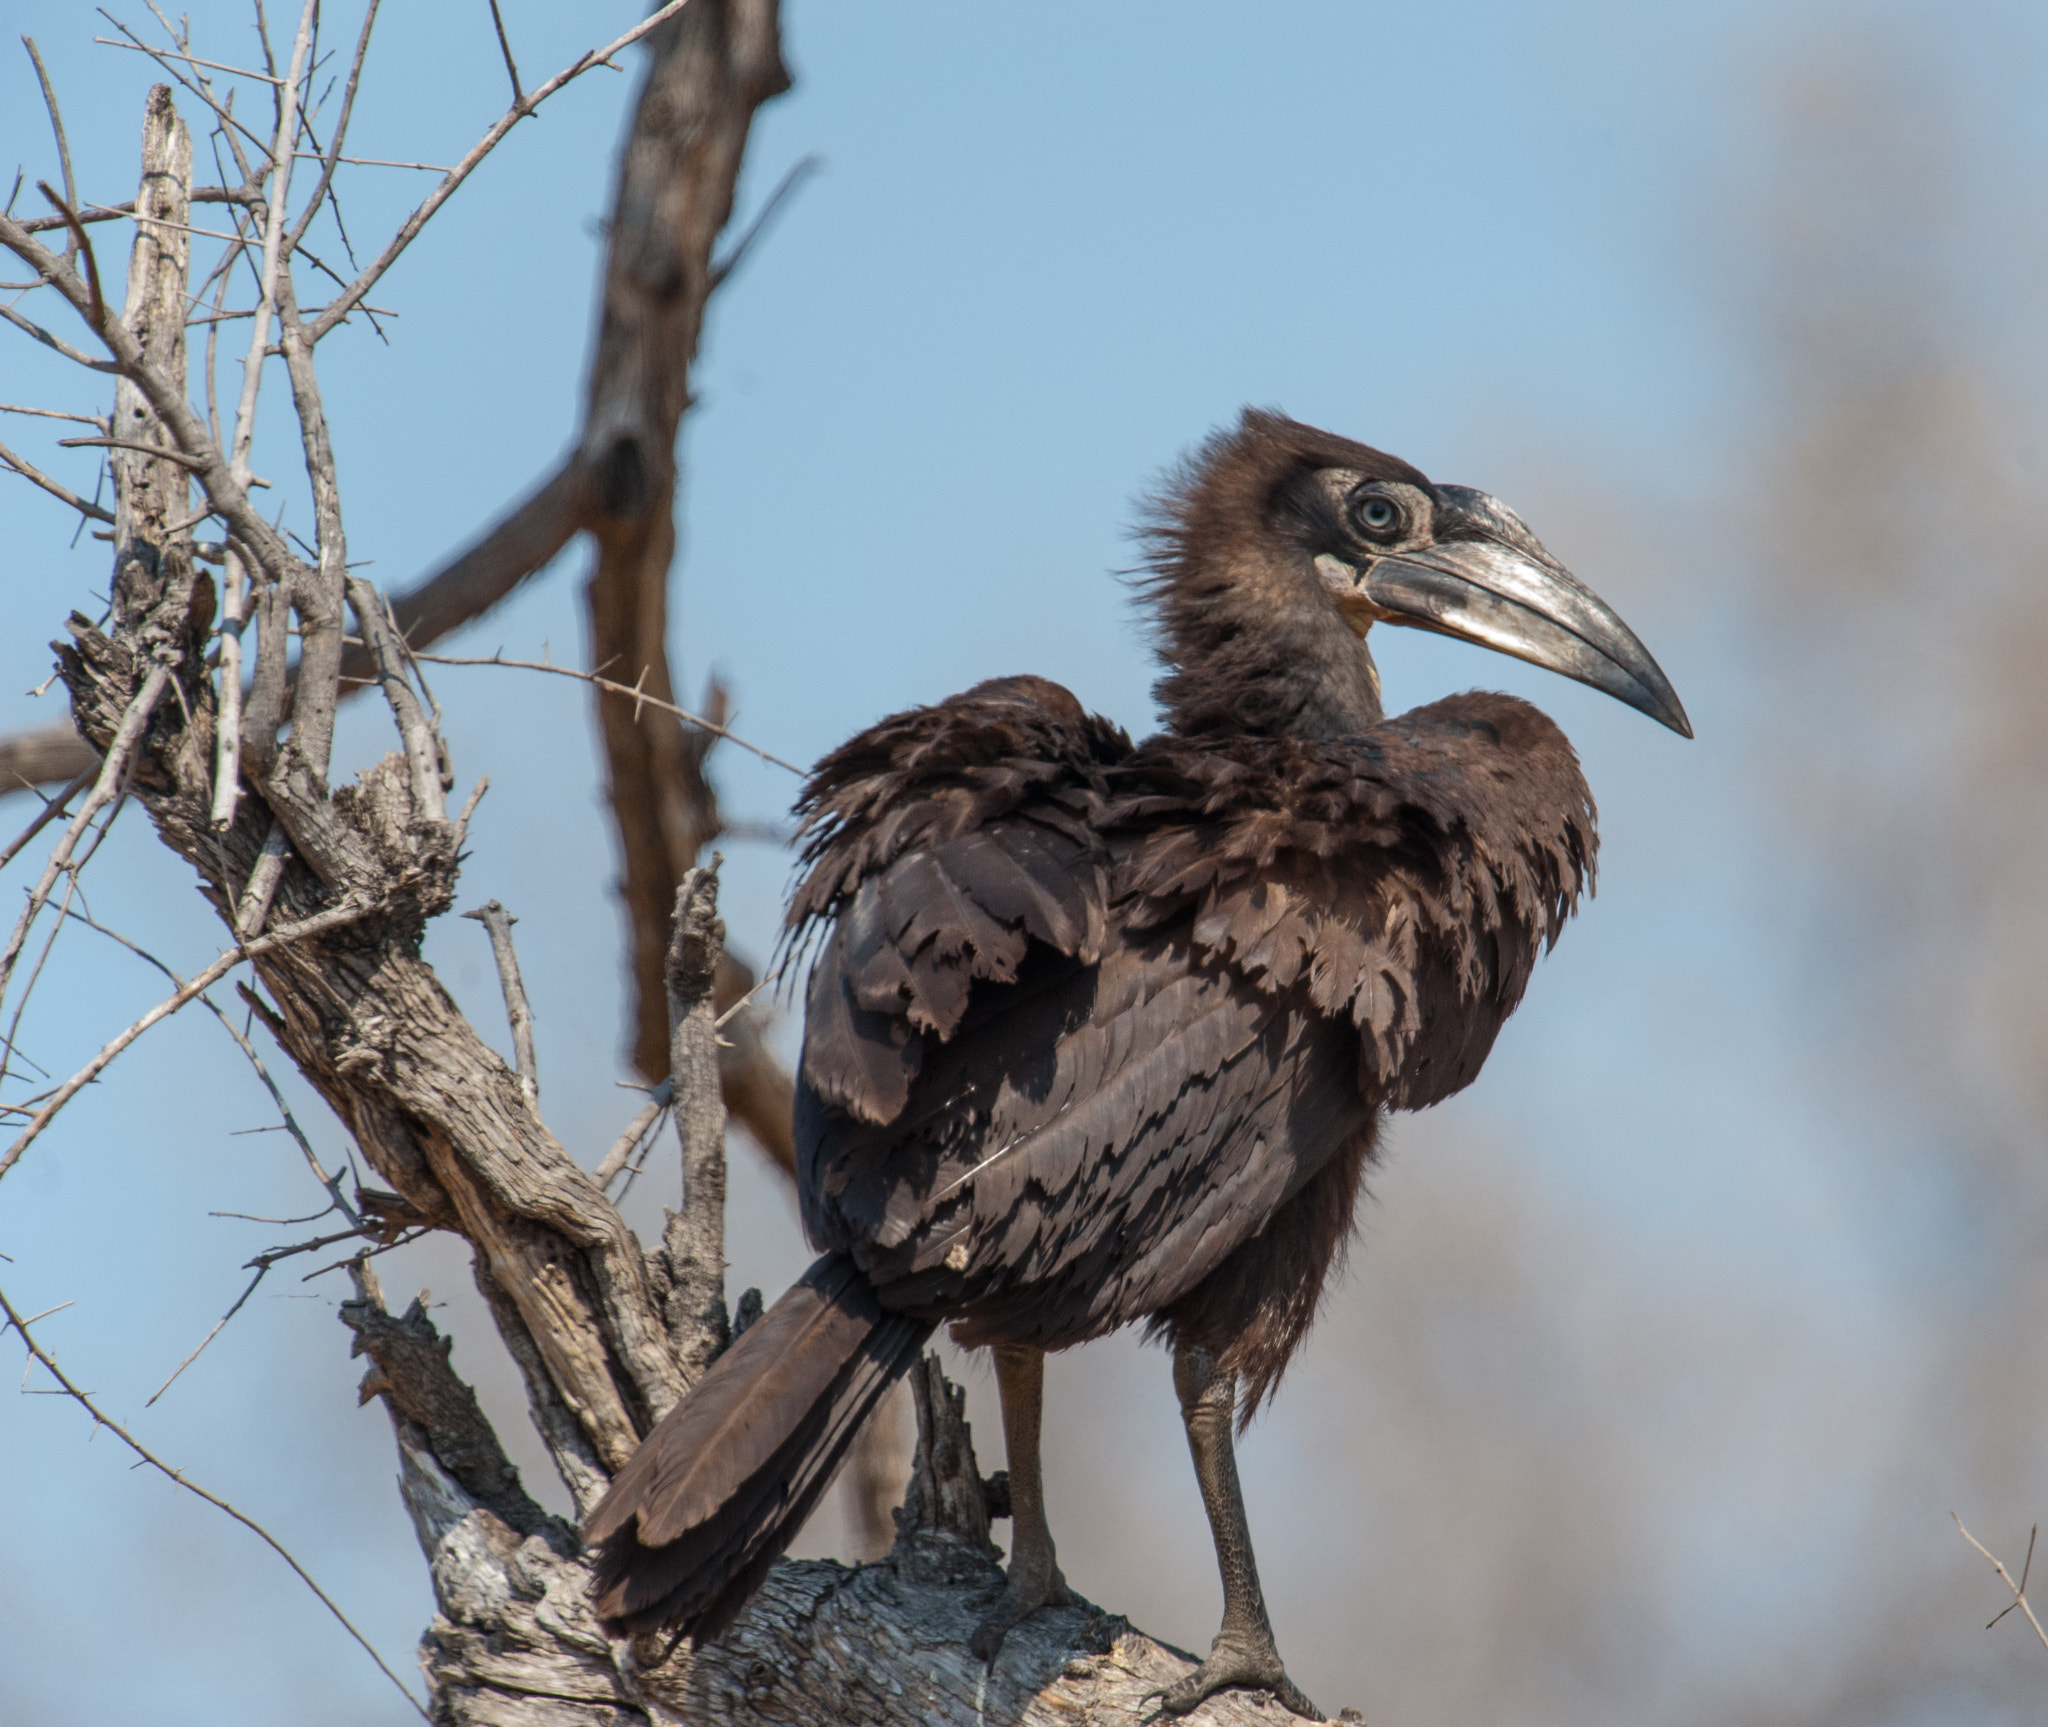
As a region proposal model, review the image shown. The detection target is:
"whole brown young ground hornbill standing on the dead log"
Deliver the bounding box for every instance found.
[586,412,1692,1715]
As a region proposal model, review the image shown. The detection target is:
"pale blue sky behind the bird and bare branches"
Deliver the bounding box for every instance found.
[0,0,2044,1723]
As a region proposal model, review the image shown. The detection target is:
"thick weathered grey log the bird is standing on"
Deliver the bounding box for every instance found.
[380,1315,1327,1727]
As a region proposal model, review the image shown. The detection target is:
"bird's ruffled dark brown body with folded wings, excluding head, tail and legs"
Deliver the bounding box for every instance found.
[791,678,1593,1389]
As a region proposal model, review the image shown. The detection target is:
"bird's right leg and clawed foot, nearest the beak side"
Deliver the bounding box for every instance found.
[1163,1344,1323,1721]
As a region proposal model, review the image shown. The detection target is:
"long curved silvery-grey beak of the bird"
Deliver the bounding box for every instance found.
[1354,486,1692,738]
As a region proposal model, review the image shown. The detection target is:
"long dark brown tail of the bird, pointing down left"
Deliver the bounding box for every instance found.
[584,1254,932,1643]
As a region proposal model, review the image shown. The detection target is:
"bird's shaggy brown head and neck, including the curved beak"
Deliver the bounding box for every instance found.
[1145,410,1692,738]
